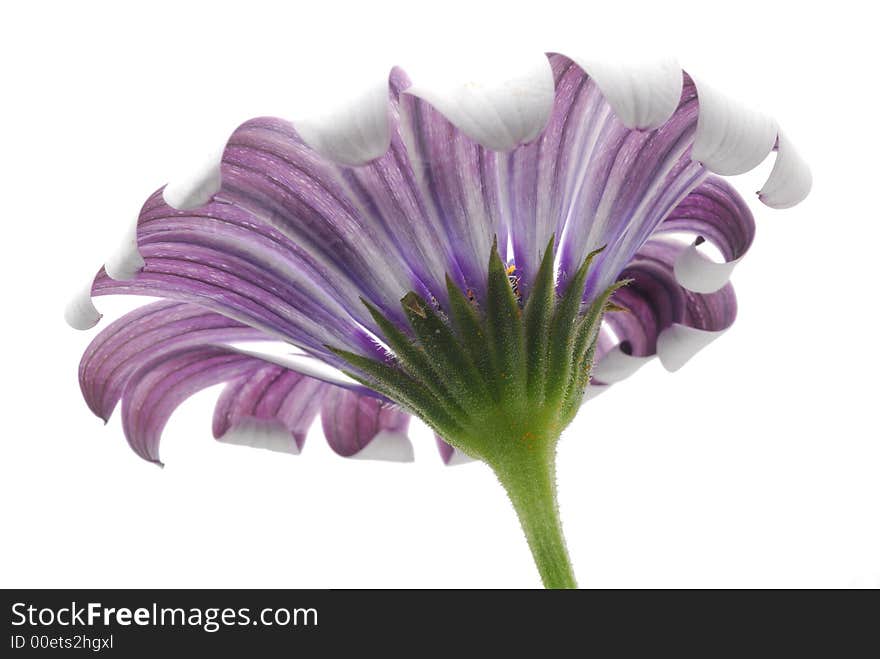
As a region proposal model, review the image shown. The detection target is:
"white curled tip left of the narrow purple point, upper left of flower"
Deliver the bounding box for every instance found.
[294,78,391,166]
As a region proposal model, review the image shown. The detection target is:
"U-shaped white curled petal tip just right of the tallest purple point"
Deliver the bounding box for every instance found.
[570,57,684,130]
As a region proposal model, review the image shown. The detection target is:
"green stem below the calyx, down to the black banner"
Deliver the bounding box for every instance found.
[495,442,577,588]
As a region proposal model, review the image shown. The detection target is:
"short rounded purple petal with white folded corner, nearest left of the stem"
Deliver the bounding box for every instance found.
[321,387,413,462]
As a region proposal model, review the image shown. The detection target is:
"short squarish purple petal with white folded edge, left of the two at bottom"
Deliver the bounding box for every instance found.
[213,365,332,453]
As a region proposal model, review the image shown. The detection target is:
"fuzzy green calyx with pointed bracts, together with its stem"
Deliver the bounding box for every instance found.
[331,238,626,587]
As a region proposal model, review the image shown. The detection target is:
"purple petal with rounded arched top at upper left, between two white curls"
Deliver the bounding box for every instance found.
[216,119,418,327]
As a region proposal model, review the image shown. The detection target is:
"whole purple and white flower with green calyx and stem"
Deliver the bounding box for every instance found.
[67,54,811,587]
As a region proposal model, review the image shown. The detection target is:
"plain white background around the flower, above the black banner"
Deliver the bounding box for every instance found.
[0,0,880,587]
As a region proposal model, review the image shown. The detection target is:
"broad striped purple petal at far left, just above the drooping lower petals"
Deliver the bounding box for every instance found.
[93,192,377,366]
